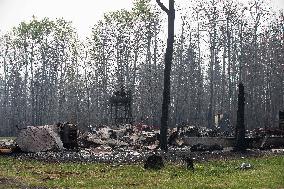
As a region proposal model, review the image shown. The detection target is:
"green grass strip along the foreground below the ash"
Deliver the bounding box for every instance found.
[0,156,284,188]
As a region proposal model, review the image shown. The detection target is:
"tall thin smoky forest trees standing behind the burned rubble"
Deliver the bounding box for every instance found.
[0,0,284,136]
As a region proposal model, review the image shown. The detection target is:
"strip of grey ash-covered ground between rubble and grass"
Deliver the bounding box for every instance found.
[11,148,284,164]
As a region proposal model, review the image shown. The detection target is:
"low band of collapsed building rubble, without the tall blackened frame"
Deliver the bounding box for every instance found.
[8,123,284,155]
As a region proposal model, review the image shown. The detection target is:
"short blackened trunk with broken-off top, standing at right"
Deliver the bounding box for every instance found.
[235,83,247,151]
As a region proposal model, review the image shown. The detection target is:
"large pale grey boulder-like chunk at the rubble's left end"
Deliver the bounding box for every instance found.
[16,125,63,152]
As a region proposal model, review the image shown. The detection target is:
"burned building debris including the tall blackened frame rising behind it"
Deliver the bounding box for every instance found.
[0,101,284,163]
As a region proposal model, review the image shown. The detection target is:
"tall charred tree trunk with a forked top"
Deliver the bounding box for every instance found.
[156,0,175,151]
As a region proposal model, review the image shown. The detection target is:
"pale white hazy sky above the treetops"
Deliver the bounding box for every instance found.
[0,0,284,36]
